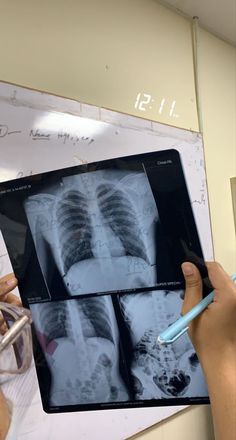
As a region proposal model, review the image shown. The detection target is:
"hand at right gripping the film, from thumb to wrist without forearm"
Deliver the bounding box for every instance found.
[182,263,236,369]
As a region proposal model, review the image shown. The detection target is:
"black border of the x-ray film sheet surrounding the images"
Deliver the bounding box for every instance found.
[0,149,211,413]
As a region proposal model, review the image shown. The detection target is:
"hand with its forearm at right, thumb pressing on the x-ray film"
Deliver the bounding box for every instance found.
[182,263,236,440]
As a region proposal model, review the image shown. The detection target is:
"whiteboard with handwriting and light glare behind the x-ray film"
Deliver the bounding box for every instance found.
[0,82,213,440]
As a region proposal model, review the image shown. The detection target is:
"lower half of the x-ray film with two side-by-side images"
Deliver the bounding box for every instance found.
[30,290,208,411]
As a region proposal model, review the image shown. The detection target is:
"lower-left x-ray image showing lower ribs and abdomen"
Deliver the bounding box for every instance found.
[31,297,129,405]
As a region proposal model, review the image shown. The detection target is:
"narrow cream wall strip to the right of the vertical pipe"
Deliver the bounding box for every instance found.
[199,31,236,273]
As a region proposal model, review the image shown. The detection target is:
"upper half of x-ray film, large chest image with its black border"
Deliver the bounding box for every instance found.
[0,150,207,300]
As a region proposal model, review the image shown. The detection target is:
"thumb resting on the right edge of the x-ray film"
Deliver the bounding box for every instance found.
[181,262,202,315]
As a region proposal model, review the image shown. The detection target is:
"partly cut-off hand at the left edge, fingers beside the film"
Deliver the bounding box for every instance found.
[0,274,18,440]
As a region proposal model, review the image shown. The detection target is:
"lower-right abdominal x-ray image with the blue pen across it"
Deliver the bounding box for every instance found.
[120,291,208,400]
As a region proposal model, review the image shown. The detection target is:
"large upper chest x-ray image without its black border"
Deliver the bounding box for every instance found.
[25,170,158,297]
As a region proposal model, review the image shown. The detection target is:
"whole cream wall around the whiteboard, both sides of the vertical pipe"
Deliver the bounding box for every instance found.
[0,0,236,440]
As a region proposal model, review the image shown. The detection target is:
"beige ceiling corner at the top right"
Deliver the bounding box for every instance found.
[159,0,236,46]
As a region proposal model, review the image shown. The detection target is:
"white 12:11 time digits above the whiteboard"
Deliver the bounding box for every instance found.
[134,92,179,118]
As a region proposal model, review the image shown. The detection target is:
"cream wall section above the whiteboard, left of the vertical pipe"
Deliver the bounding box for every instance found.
[0,0,198,130]
